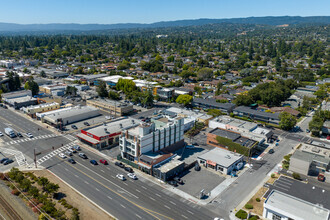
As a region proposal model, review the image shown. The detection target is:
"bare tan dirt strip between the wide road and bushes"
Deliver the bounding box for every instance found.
[33,170,113,220]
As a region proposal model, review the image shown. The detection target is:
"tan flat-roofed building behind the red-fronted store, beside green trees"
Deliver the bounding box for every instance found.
[86,99,134,116]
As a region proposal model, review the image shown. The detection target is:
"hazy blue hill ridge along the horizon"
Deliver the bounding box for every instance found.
[0,16,330,32]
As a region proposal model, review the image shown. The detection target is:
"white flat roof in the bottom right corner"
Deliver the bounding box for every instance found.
[265,190,330,220]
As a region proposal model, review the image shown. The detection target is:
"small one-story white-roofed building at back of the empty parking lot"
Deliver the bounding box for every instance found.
[197,148,243,175]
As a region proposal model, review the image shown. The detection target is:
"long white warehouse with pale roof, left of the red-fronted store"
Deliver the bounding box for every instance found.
[42,106,100,129]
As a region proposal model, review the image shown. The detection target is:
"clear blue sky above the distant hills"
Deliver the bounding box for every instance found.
[0,0,330,24]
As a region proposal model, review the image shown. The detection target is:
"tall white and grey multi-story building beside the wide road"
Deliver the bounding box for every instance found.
[119,116,184,162]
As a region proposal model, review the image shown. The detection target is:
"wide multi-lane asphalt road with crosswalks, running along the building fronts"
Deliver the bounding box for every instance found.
[0,109,219,219]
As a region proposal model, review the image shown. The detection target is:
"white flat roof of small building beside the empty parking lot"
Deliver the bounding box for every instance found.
[197,148,243,167]
